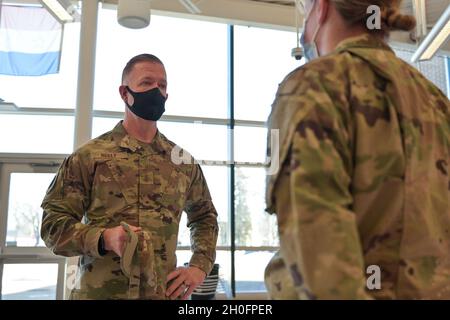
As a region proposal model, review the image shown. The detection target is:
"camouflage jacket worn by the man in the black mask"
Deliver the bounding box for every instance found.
[41,122,218,299]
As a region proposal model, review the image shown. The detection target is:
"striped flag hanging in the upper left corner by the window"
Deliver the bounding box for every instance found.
[0,5,62,76]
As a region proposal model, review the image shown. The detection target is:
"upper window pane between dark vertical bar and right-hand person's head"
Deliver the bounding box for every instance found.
[234,26,300,121]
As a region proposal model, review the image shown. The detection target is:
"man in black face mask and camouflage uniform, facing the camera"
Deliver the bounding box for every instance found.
[41,55,218,299]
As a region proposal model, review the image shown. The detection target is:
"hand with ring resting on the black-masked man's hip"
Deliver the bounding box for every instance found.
[166,267,206,300]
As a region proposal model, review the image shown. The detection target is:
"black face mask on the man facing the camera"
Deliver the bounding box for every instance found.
[125,86,166,121]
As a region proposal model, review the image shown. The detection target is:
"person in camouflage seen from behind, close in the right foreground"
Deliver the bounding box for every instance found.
[266,0,450,299]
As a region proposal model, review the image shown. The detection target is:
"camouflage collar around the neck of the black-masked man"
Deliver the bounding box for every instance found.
[112,120,165,154]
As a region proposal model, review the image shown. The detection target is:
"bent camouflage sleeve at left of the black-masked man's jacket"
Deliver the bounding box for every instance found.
[41,153,104,258]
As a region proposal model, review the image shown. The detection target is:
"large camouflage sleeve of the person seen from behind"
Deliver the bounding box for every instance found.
[277,71,370,299]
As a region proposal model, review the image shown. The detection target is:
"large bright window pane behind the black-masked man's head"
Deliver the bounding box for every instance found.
[94,9,227,118]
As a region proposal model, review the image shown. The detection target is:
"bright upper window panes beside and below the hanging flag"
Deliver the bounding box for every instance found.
[0,13,80,154]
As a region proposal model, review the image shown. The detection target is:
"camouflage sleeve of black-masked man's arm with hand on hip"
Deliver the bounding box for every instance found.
[185,165,219,275]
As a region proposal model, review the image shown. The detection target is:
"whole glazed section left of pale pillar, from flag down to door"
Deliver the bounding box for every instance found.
[0,1,80,300]
